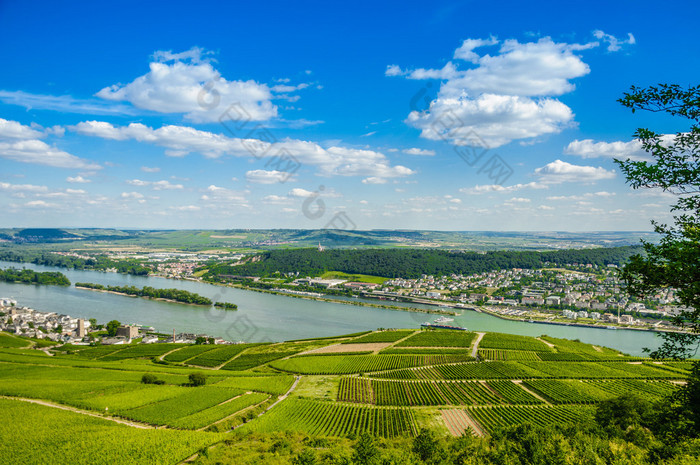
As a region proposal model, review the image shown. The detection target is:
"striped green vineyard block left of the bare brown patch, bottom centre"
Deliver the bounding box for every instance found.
[242,399,416,438]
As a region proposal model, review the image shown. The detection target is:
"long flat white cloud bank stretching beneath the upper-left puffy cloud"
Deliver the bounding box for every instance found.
[71,121,414,178]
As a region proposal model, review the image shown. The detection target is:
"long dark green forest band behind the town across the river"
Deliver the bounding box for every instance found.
[205,246,641,280]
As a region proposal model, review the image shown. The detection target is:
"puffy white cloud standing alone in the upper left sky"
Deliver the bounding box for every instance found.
[96,48,277,122]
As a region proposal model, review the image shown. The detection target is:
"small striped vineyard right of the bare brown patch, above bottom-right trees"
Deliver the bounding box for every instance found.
[466,405,593,433]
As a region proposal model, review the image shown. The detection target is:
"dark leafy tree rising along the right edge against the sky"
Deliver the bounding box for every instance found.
[615,84,700,359]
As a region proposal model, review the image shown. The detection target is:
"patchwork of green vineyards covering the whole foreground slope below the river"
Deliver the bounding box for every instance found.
[0,330,691,463]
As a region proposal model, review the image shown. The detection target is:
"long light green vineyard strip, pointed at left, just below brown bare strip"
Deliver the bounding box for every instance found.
[270,355,474,375]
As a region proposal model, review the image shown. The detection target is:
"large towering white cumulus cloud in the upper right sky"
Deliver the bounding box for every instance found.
[385,37,624,148]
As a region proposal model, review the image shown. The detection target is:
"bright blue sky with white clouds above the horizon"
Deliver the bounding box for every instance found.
[0,1,700,231]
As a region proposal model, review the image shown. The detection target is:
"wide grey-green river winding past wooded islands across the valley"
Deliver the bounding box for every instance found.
[0,261,660,355]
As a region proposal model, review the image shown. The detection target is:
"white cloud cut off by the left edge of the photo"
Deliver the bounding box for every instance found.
[0,118,102,170]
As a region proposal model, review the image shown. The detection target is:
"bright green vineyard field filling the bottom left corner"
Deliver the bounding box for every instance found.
[0,399,225,465]
